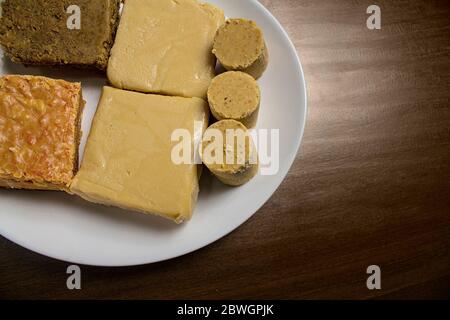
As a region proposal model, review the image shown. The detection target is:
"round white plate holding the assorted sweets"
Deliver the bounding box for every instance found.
[0,0,306,266]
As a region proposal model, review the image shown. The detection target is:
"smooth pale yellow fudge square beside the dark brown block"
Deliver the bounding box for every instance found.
[107,0,225,98]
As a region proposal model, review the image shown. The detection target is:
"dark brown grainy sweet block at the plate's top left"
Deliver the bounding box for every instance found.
[0,0,121,70]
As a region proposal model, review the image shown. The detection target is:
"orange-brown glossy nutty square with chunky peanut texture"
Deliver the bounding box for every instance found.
[0,76,83,190]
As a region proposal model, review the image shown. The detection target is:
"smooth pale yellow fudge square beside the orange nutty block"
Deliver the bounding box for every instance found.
[71,87,209,223]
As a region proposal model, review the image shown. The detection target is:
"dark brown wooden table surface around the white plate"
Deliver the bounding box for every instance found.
[0,0,450,299]
